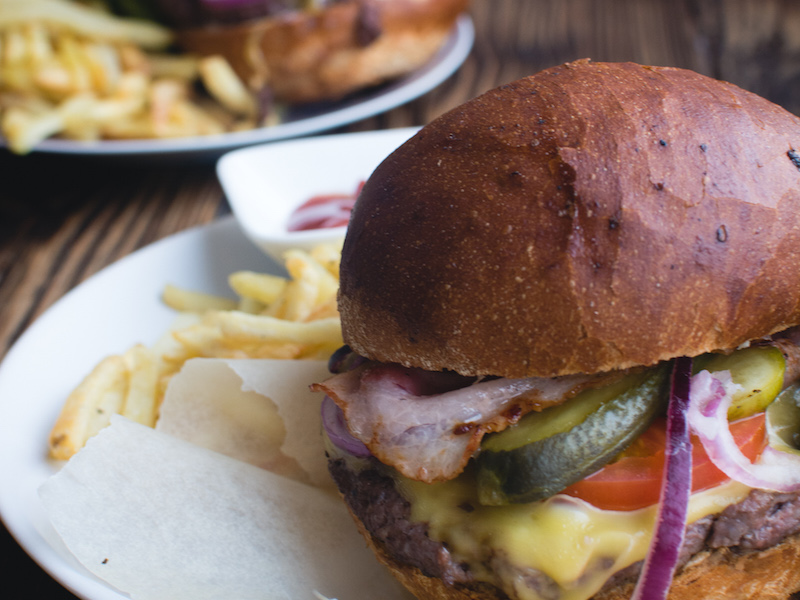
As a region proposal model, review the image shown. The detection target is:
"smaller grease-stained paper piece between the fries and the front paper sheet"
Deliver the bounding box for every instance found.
[156,358,333,488]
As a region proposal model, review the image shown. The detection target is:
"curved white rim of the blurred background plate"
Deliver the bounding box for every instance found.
[10,15,475,158]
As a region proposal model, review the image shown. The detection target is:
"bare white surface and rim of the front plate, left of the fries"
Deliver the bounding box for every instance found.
[0,218,279,600]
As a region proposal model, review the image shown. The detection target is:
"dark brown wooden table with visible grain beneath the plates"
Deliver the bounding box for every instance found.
[0,0,800,599]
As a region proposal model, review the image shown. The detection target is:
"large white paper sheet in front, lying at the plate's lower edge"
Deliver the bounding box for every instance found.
[40,417,408,600]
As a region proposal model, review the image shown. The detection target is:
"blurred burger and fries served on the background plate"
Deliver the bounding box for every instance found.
[0,0,468,153]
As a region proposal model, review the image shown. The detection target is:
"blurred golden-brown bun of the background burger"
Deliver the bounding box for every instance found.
[172,0,468,104]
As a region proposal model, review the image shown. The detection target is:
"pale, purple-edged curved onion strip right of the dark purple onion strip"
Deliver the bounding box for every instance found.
[689,371,800,492]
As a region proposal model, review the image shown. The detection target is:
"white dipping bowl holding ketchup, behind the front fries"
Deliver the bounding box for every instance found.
[217,127,418,264]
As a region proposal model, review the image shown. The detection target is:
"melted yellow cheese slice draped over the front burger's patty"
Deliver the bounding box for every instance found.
[398,476,750,600]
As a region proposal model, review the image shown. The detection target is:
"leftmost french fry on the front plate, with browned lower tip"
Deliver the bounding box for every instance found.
[49,355,128,460]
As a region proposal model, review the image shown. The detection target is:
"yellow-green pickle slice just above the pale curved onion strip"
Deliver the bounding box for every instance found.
[702,346,786,421]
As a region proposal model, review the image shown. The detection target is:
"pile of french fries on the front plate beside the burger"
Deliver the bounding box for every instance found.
[49,245,343,460]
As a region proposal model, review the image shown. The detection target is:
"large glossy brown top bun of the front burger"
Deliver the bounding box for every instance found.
[339,60,800,377]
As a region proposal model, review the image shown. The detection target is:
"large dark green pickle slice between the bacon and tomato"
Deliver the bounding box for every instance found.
[475,367,667,506]
